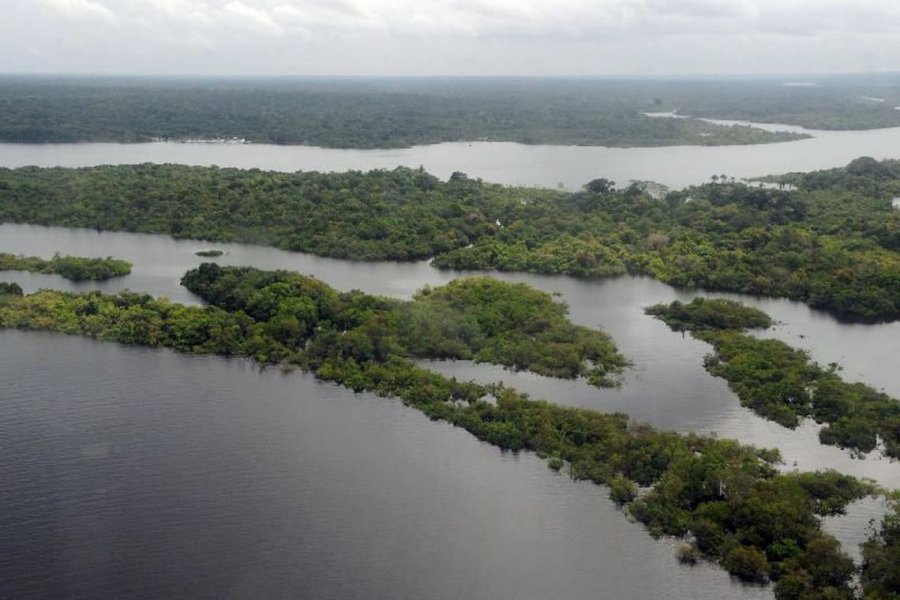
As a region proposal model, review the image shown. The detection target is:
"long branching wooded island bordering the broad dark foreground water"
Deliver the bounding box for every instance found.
[0,264,893,600]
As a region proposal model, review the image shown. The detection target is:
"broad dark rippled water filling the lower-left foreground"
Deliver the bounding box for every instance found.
[0,331,771,600]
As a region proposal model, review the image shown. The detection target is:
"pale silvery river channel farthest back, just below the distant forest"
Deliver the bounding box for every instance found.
[0,121,900,189]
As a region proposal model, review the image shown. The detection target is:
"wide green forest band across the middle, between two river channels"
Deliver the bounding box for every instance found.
[0,158,900,320]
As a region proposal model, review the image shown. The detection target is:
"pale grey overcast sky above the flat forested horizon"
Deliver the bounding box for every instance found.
[0,0,900,76]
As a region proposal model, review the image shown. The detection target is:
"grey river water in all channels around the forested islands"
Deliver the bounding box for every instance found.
[0,130,900,599]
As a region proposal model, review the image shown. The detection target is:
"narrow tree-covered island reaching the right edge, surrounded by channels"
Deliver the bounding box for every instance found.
[646,298,900,459]
